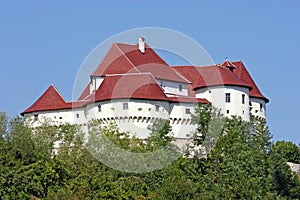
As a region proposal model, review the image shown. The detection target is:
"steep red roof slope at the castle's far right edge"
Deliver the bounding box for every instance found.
[232,61,269,103]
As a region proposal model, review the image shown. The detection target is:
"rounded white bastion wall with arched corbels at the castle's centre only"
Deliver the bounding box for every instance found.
[87,99,169,139]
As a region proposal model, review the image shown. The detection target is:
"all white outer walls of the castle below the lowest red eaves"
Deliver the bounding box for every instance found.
[25,86,265,143]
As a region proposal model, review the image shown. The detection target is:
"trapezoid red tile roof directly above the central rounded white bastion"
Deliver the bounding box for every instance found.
[95,73,168,101]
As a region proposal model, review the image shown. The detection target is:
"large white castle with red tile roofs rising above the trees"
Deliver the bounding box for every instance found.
[21,37,269,143]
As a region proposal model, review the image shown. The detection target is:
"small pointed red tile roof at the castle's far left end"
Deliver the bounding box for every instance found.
[21,85,72,115]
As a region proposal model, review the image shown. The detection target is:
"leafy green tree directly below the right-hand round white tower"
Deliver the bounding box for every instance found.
[201,117,272,199]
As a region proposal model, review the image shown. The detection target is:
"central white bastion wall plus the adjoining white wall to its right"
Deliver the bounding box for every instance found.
[87,99,197,139]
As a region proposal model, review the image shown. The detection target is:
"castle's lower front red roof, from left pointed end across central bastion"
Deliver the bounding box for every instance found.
[21,73,209,116]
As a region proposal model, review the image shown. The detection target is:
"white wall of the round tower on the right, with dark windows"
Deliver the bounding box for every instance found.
[196,85,250,121]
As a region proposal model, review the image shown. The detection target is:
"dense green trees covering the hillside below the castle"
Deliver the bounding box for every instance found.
[0,105,300,199]
